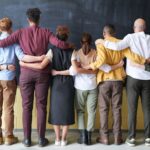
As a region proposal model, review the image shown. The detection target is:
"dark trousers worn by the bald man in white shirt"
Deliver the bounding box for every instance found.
[127,76,150,139]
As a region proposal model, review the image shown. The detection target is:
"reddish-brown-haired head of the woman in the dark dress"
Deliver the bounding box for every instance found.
[56,25,69,41]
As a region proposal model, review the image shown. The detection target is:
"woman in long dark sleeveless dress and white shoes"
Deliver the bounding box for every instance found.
[20,26,75,146]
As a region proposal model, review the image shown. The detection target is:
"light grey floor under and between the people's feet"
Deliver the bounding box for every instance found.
[0,131,150,150]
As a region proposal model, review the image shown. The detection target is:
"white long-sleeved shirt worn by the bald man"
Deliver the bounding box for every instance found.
[104,32,150,80]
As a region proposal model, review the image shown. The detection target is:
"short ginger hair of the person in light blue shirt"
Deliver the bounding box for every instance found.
[0,17,12,31]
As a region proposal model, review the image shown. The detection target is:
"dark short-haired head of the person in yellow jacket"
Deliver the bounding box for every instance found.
[103,24,116,38]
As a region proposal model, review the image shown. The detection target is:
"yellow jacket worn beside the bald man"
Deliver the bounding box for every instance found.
[90,37,145,84]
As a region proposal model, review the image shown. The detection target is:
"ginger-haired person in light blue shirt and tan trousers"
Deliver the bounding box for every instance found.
[0,17,44,145]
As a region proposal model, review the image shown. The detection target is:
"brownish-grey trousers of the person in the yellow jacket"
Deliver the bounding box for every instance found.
[98,81,123,137]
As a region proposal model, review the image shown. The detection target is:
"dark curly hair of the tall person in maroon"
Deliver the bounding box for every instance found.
[26,8,41,23]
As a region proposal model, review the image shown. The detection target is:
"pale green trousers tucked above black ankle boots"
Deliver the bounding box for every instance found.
[75,88,98,131]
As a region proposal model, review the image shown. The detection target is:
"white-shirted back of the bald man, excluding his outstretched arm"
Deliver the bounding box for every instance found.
[125,32,150,79]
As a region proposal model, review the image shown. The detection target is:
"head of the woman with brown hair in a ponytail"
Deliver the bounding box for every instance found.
[81,32,92,54]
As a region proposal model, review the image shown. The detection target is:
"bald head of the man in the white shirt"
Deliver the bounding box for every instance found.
[133,18,146,32]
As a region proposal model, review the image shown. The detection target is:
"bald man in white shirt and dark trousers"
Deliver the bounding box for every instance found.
[96,18,150,146]
